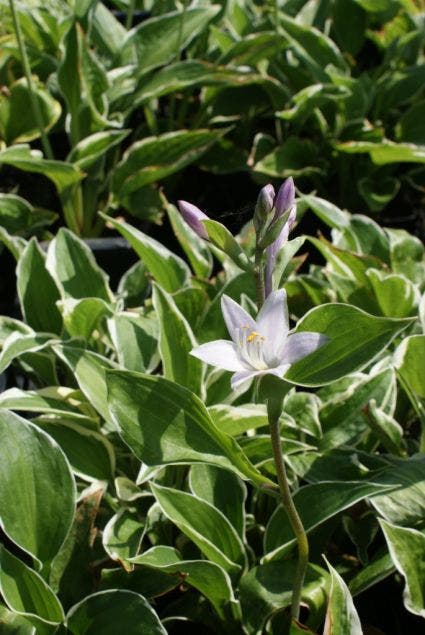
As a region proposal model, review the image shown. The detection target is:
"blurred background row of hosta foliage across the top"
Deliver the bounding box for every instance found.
[0,0,425,236]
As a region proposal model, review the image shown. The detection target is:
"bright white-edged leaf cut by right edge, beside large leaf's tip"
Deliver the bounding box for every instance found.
[394,335,425,398]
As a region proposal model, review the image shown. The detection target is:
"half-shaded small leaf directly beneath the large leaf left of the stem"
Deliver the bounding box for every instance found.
[189,463,247,539]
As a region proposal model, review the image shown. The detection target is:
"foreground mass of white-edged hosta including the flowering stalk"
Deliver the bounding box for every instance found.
[0,181,425,635]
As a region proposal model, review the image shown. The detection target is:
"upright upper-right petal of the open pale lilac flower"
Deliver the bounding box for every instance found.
[256,289,289,358]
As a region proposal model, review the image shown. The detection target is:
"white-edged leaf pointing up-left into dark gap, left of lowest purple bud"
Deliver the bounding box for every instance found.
[102,215,190,293]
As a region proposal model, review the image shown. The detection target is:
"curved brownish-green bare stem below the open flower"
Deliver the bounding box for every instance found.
[267,408,308,620]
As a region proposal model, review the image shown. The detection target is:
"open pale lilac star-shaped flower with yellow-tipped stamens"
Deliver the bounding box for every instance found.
[191,289,328,388]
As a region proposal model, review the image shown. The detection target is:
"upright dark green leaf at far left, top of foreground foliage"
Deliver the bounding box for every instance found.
[16,238,62,334]
